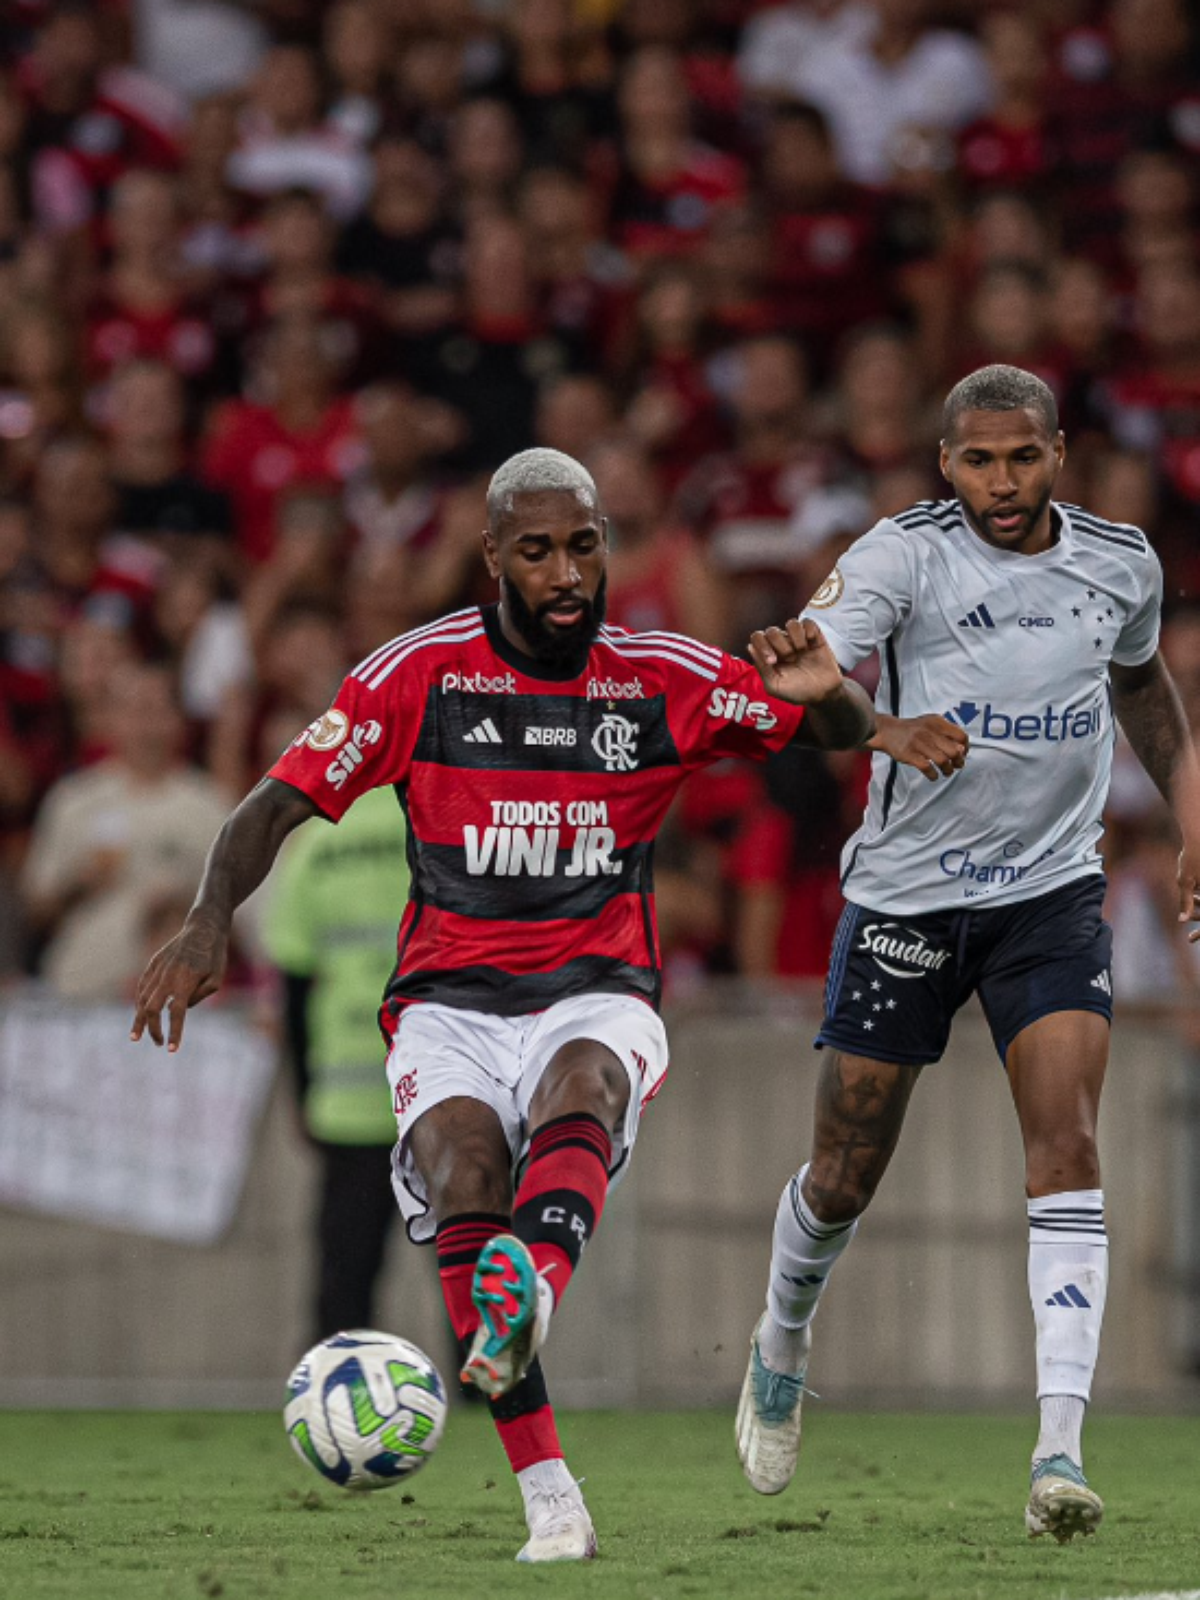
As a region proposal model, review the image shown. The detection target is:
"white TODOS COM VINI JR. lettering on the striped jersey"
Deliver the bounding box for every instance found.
[462,800,621,878]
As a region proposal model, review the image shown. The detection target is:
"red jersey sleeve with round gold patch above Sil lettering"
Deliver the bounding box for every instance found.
[267,667,426,822]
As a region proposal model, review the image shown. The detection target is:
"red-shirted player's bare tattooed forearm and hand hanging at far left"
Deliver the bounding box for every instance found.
[130,778,317,1051]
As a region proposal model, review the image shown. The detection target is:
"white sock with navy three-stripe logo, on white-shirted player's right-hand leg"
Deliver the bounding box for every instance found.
[1029,1189,1109,1464]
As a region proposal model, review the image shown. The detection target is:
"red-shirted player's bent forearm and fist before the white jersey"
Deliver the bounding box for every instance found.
[750,618,875,750]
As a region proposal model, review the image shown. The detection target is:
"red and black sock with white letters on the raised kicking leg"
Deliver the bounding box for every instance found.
[512,1112,613,1304]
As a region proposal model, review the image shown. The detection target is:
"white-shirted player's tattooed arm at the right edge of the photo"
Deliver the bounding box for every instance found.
[1109,651,1200,941]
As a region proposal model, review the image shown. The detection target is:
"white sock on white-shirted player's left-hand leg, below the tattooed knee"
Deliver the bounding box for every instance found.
[758,1166,858,1373]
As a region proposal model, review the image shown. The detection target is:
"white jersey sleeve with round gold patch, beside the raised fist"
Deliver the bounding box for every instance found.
[802,520,915,672]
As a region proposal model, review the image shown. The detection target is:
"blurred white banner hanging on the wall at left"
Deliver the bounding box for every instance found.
[0,997,275,1245]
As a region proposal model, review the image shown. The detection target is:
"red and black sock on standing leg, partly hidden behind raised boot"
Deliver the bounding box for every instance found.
[437,1211,563,1472]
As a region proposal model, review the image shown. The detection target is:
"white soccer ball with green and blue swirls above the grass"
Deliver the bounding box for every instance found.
[283,1328,446,1490]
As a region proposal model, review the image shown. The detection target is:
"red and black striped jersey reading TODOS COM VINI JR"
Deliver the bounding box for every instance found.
[270,606,803,1027]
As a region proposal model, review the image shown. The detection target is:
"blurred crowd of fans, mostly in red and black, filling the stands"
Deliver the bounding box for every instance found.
[0,0,1200,998]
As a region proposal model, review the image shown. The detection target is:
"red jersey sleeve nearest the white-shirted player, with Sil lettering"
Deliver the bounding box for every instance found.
[672,654,805,766]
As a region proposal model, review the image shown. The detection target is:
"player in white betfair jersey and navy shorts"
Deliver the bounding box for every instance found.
[736,366,1200,1541]
